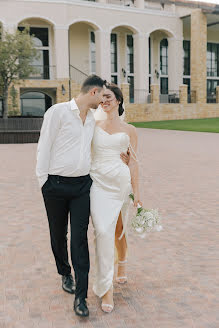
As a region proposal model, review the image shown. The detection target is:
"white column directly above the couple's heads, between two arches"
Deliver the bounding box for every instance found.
[95,30,111,82]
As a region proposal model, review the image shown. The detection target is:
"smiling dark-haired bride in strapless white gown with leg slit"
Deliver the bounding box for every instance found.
[90,84,141,312]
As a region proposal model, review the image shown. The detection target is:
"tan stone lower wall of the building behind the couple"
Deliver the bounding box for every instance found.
[7,79,219,122]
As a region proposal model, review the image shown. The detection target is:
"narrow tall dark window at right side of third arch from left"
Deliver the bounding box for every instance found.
[126,35,134,103]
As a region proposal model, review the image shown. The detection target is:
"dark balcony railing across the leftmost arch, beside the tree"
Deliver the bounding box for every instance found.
[20,65,56,80]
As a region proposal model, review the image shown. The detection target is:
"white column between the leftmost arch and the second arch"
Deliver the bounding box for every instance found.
[54,26,69,79]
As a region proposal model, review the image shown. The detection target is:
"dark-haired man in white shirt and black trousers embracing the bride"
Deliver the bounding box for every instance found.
[36,75,126,317]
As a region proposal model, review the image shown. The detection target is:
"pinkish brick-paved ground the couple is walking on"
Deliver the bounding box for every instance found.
[0,129,219,328]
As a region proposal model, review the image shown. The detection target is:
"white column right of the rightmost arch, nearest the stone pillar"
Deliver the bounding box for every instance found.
[168,37,183,92]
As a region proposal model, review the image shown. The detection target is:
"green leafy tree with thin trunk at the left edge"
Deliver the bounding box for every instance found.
[0,28,38,119]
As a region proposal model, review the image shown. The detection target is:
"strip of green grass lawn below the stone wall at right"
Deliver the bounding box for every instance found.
[130,117,219,133]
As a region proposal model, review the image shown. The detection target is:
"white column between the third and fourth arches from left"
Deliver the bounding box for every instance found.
[133,33,149,103]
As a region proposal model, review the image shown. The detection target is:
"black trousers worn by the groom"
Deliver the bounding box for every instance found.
[42,175,92,298]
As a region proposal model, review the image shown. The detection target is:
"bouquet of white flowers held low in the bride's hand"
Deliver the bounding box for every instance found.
[129,194,163,238]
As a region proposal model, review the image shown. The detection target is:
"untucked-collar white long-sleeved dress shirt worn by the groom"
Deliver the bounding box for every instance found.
[36,99,95,187]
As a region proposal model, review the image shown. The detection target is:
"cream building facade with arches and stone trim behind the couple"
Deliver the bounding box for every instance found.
[0,0,219,120]
